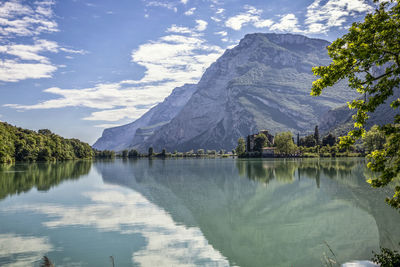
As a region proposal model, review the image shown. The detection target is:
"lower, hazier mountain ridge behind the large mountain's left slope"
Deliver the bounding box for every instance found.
[93,84,196,151]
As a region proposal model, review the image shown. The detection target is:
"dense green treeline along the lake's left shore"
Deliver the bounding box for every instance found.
[0,122,94,163]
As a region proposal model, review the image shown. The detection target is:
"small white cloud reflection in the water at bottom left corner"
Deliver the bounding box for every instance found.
[0,234,54,267]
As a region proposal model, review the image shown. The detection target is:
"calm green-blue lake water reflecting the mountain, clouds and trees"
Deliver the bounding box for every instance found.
[0,159,400,266]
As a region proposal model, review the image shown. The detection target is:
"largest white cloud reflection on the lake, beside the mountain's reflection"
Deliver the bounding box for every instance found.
[3,186,229,266]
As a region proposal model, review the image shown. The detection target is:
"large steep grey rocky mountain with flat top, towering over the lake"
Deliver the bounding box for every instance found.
[136,33,357,151]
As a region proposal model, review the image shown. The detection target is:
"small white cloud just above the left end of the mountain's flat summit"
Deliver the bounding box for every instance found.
[225,6,273,31]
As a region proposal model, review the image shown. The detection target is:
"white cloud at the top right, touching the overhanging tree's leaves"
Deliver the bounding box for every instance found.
[305,0,372,33]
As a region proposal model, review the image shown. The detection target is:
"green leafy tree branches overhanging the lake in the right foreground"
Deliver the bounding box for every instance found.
[311,0,400,209]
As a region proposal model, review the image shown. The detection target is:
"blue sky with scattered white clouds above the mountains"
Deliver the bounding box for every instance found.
[0,0,373,144]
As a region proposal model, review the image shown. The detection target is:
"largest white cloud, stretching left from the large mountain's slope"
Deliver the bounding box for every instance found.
[6,30,223,121]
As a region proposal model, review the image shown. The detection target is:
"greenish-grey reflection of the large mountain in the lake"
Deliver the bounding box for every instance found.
[95,159,400,266]
